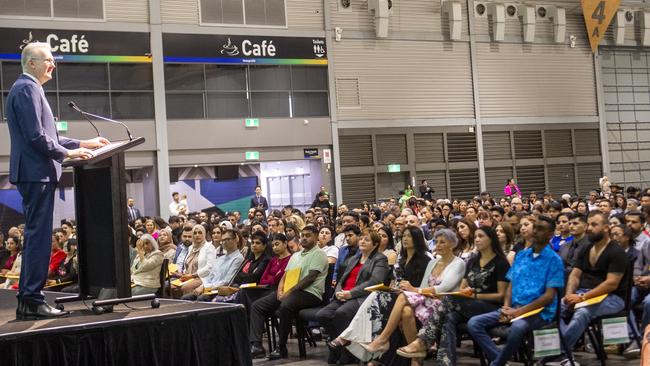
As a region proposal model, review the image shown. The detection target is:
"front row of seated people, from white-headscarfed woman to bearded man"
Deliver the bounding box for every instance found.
[153,211,630,365]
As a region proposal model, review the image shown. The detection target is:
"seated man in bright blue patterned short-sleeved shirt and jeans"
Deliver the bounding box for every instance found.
[467,216,564,366]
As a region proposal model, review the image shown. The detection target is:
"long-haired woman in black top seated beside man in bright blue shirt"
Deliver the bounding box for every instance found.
[397,226,510,366]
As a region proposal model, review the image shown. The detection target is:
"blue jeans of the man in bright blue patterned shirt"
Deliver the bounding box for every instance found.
[467,309,547,366]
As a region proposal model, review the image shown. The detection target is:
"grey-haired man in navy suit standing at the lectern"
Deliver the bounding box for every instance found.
[6,43,109,320]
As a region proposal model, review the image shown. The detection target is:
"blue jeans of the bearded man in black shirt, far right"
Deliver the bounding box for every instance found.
[560,289,625,349]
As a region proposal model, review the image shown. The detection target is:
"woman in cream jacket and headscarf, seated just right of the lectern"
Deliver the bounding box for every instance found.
[131,234,164,296]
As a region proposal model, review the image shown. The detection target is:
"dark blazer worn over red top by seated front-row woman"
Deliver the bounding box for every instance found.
[334,251,388,299]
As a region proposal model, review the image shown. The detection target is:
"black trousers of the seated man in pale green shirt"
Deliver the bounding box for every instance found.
[249,290,321,347]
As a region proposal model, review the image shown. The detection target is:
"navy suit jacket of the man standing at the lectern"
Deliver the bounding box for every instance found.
[6,74,79,183]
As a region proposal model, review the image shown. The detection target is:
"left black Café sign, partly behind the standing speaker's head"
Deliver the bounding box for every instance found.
[0,28,151,63]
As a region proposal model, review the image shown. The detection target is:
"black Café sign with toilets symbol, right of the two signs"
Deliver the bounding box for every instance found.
[163,33,327,65]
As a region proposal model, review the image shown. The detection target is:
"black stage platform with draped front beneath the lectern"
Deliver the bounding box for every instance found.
[0,290,252,366]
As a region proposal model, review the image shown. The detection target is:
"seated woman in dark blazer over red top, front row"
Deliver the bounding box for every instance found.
[316,229,388,364]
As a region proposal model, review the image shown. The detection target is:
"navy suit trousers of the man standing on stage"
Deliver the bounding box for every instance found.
[16,182,56,303]
